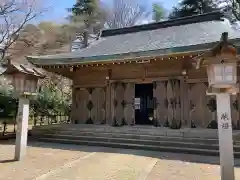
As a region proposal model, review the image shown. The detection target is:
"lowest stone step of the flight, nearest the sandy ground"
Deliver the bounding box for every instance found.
[38,138,240,158]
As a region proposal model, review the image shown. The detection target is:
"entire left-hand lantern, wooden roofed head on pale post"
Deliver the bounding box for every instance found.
[2,60,45,160]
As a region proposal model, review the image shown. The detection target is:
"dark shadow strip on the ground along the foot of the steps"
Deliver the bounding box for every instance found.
[0,140,240,167]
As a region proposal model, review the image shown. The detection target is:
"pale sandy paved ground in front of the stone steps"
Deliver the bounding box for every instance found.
[0,142,240,180]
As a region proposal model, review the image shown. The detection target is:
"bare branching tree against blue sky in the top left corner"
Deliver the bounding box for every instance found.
[0,0,43,60]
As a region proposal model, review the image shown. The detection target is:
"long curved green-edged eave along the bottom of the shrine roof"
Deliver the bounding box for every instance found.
[26,38,240,66]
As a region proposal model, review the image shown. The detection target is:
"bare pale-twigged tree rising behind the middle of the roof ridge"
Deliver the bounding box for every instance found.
[104,0,150,28]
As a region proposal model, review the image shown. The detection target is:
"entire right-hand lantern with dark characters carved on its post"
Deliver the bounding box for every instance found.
[195,32,239,180]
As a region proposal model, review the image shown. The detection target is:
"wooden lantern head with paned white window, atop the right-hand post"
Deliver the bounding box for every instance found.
[194,32,240,95]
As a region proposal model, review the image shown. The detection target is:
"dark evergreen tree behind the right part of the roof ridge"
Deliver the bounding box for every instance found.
[169,0,218,19]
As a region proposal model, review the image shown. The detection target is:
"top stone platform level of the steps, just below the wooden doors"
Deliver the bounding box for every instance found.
[33,124,240,139]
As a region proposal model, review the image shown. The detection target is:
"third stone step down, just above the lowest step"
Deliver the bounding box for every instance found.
[42,134,223,152]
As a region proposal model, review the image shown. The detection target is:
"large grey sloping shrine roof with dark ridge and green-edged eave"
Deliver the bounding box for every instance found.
[28,12,240,65]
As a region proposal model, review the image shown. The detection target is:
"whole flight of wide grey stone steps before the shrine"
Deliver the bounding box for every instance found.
[32,125,240,158]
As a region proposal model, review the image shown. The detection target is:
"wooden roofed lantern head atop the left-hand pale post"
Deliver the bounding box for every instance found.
[2,60,45,96]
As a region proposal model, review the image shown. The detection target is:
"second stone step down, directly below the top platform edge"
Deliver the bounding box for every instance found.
[43,131,218,144]
